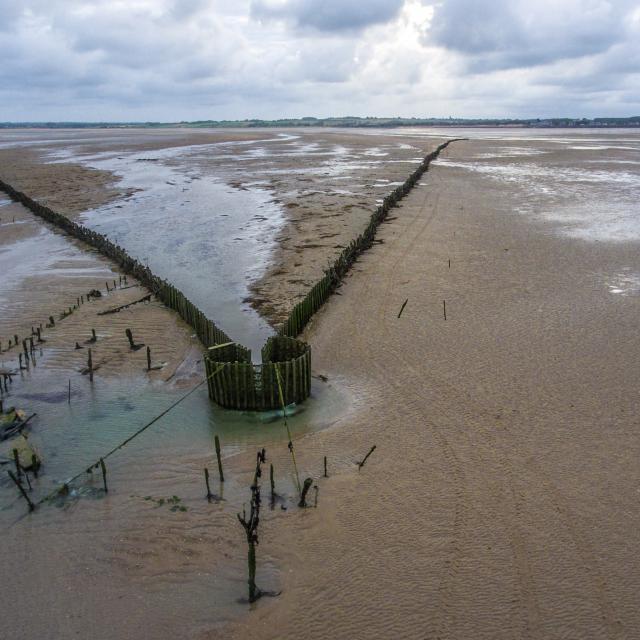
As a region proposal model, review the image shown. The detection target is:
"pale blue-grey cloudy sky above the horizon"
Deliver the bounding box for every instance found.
[0,0,640,121]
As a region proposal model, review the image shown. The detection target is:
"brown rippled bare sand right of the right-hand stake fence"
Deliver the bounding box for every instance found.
[211,141,640,640]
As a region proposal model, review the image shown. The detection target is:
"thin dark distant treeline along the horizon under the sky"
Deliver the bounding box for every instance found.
[0,116,640,129]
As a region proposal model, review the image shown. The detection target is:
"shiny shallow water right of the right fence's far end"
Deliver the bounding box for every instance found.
[430,129,640,242]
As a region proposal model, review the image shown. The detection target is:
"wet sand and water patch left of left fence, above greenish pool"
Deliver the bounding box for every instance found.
[0,198,201,385]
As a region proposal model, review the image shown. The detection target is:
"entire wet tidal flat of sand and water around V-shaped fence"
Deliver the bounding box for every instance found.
[0,129,640,638]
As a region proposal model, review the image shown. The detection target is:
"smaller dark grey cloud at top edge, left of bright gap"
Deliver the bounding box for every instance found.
[251,0,404,32]
